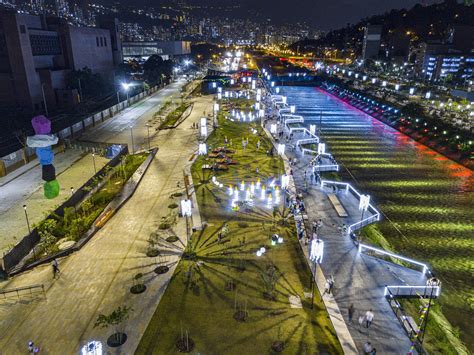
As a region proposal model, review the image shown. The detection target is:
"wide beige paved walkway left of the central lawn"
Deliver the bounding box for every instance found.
[0,93,212,354]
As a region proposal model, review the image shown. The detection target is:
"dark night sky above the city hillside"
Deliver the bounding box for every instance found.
[183,0,428,30]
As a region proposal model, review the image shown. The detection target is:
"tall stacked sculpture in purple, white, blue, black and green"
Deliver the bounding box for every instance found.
[26,115,59,199]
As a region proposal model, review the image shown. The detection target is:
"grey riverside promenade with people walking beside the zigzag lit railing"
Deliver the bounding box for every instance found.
[269,123,426,354]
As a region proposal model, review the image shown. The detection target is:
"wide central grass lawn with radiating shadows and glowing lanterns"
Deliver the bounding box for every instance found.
[136,96,342,354]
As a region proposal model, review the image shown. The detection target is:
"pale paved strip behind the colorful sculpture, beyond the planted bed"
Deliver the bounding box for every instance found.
[0,149,108,251]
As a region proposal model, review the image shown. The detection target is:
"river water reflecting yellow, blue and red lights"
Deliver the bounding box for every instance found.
[280,86,474,350]
